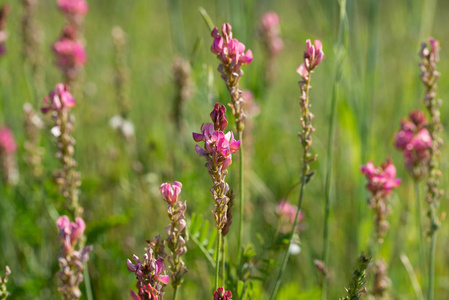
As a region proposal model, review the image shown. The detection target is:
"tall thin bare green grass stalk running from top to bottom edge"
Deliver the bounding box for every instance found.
[321,0,348,300]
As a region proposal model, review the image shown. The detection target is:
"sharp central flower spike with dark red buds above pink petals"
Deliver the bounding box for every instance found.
[193,103,240,230]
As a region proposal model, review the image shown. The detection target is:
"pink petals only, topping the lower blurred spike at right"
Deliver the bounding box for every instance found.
[361,158,401,197]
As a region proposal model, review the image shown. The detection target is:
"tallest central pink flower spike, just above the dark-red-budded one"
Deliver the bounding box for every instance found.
[211,23,253,132]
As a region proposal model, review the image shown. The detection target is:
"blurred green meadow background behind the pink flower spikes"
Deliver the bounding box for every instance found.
[0,0,449,299]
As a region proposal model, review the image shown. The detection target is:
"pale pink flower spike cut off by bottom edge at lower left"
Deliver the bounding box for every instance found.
[56,216,92,299]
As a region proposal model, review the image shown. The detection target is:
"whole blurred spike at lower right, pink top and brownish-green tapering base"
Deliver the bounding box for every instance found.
[361,158,401,243]
